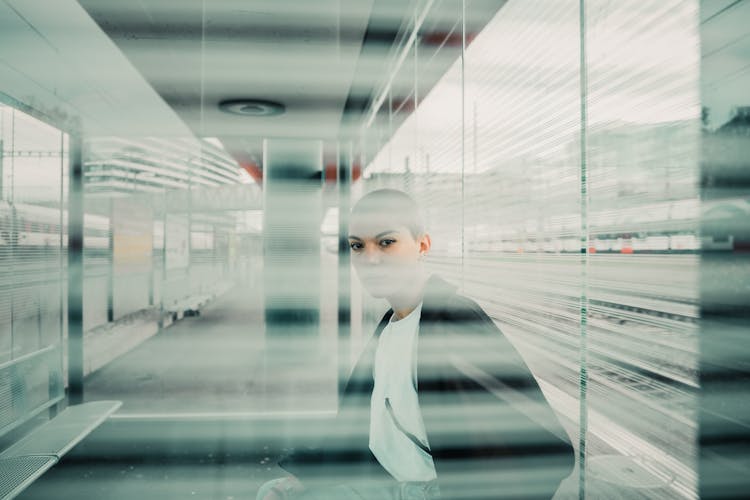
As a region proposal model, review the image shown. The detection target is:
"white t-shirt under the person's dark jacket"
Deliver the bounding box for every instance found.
[370,304,437,482]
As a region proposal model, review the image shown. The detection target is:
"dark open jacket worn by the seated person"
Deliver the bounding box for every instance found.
[281,276,575,499]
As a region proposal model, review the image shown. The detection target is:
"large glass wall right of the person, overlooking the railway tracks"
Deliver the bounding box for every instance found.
[360,0,701,498]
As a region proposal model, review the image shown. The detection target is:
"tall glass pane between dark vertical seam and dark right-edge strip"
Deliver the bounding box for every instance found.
[585,0,700,498]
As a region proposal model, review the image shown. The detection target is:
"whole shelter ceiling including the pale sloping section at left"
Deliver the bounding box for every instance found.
[0,0,505,172]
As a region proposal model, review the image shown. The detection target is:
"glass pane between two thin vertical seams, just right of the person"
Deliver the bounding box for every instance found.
[463,1,582,495]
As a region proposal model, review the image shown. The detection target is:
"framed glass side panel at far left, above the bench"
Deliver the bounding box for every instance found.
[0,103,68,436]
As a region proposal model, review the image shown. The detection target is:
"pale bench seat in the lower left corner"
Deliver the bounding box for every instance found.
[0,401,122,499]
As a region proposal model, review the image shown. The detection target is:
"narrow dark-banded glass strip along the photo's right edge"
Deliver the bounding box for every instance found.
[699,0,750,498]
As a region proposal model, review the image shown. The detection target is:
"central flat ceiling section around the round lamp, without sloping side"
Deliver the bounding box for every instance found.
[79,0,414,168]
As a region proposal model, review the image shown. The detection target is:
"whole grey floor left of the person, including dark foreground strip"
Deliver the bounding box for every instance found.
[19,289,336,500]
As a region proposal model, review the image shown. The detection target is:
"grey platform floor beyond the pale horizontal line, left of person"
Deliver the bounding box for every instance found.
[85,287,336,415]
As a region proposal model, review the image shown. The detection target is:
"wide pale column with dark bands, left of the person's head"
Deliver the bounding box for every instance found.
[263,139,323,409]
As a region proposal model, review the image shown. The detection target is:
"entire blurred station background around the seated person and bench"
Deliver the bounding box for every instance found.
[0,0,750,499]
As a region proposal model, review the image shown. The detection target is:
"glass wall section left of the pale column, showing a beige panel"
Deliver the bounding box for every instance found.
[84,136,260,410]
